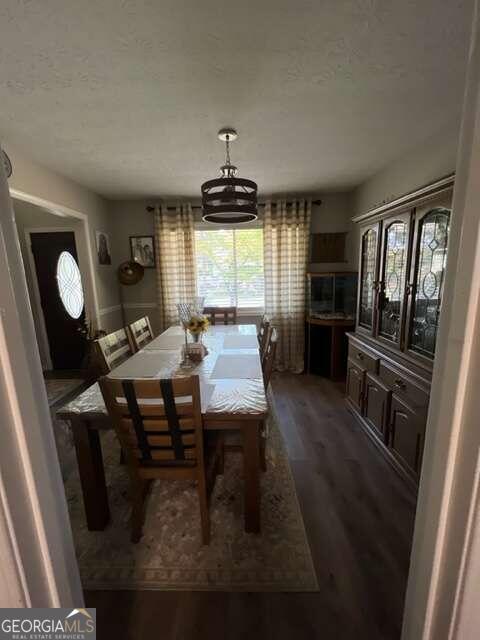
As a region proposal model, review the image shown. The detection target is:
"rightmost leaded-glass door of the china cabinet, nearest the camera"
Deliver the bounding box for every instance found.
[408,207,450,358]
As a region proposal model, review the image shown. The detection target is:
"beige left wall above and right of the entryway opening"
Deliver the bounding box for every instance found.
[2,140,120,330]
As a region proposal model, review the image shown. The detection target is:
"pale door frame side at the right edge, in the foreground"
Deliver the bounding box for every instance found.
[402,0,480,640]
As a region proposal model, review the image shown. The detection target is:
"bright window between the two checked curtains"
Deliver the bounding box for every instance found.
[195,229,265,309]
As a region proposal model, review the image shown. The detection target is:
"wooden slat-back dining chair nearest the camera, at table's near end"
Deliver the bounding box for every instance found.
[99,376,223,544]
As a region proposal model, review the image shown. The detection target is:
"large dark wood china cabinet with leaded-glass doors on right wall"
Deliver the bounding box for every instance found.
[346,176,453,486]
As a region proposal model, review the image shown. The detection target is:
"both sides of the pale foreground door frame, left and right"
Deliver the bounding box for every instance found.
[0,3,480,628]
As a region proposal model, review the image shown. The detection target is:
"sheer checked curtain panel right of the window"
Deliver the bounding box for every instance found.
[264,200,312,373]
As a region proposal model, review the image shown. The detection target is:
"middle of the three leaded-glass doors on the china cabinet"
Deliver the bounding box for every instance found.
[377,212,411,345]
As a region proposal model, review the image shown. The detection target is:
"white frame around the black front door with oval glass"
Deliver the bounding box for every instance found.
[24,227,85,369]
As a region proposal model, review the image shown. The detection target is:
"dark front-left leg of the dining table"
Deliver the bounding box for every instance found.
[71,417,110,531]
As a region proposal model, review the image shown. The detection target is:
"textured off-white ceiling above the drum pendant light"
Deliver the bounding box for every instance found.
[0,0,472,198]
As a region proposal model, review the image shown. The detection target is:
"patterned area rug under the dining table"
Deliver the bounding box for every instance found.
[65,410,318,591]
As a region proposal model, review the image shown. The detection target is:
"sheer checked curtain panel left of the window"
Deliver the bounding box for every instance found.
[155,203,197,331]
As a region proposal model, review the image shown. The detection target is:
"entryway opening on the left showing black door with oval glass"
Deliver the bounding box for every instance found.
[14,195,98,378]
